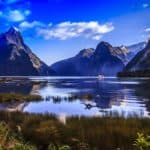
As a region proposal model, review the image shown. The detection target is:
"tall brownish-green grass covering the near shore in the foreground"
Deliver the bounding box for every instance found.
[0,112,150,150]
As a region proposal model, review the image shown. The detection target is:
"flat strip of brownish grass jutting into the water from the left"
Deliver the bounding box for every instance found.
[0,93,43,102]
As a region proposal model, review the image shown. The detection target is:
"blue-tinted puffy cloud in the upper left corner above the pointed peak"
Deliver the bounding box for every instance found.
[0,9,31,22]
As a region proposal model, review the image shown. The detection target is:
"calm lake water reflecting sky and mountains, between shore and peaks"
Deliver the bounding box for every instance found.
[0,77,150,117]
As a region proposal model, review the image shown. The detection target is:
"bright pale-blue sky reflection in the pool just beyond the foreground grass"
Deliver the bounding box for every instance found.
[24,100,99,116]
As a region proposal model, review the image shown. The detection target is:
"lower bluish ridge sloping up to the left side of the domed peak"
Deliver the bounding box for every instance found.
[51,48,94,76]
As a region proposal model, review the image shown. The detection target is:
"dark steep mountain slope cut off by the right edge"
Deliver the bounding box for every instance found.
[124,40,150,71]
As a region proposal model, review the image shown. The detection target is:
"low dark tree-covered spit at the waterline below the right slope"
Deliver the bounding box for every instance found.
[117,70,150,77]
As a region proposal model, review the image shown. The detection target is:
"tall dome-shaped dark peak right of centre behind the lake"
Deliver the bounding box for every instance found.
[87,42,126,76]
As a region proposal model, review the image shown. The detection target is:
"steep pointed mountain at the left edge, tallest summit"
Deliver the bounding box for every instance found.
[0,27,53,76]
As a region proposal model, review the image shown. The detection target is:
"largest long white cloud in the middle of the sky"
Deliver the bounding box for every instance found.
[38,21,114,40]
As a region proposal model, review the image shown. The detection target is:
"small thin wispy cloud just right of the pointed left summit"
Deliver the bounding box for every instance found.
[19,21,45,30]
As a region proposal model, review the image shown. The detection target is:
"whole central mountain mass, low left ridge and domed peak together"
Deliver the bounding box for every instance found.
[51,42,129,76]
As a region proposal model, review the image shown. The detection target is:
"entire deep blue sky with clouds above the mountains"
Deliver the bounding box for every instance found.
[0,0,150,64]
